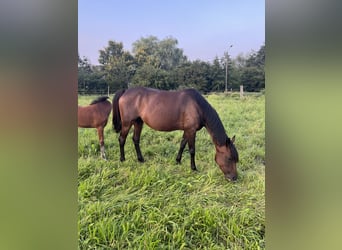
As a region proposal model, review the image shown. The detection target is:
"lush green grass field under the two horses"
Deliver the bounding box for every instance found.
[78,94,265,249]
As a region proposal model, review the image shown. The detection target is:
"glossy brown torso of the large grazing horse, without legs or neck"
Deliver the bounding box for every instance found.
[119,87,201,131]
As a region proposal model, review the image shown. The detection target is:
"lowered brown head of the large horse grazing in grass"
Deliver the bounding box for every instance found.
[215,135,239,181]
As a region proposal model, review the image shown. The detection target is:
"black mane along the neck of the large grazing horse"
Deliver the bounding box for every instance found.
[187,89,229,146]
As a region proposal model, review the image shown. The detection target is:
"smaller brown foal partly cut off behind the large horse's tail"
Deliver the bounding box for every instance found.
[78,96,112,159]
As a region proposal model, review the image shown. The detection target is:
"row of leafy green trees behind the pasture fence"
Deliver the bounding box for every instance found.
[78,36,265,94]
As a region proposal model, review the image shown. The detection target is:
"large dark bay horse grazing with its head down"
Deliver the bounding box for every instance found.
[113,87,239,181]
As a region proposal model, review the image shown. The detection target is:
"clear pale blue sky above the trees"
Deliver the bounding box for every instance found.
[78,0,265,65]
